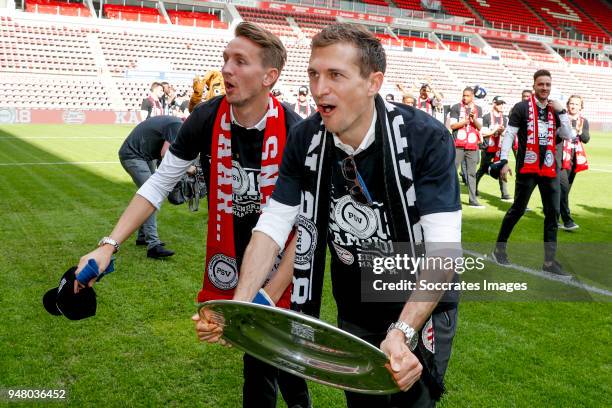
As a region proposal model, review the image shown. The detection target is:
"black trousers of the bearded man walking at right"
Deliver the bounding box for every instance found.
[497,173,561,261]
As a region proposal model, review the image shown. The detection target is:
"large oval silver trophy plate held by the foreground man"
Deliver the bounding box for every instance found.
[199,300,400,394]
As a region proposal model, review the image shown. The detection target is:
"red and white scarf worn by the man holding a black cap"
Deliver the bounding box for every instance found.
[198,96,290,306]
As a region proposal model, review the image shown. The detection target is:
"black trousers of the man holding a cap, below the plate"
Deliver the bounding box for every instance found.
[242,354,311,408]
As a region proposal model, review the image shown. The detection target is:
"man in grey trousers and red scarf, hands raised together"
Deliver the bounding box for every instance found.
[449,87,485,209]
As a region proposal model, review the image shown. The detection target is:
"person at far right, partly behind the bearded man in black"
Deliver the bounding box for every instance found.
[557,95,591,231]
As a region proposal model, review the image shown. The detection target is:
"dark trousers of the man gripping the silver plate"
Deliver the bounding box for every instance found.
[338,308,457,408]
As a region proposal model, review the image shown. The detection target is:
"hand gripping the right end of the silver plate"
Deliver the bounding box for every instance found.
[380,330,423,391]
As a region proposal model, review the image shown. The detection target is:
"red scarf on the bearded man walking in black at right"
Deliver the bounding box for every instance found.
[520,95,557,178]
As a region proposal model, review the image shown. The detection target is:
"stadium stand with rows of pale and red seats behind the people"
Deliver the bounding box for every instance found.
[0,0,612,122]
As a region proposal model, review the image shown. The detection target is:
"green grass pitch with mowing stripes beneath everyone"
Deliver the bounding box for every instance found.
[0,125,612,407]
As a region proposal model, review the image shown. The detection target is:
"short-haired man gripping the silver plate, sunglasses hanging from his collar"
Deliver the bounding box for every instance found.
[201,24,461,407]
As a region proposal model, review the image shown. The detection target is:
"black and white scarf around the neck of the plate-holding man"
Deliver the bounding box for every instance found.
[292,95,443,397]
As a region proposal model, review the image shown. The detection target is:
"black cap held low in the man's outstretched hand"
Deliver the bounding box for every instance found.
[43,266,97,320]
